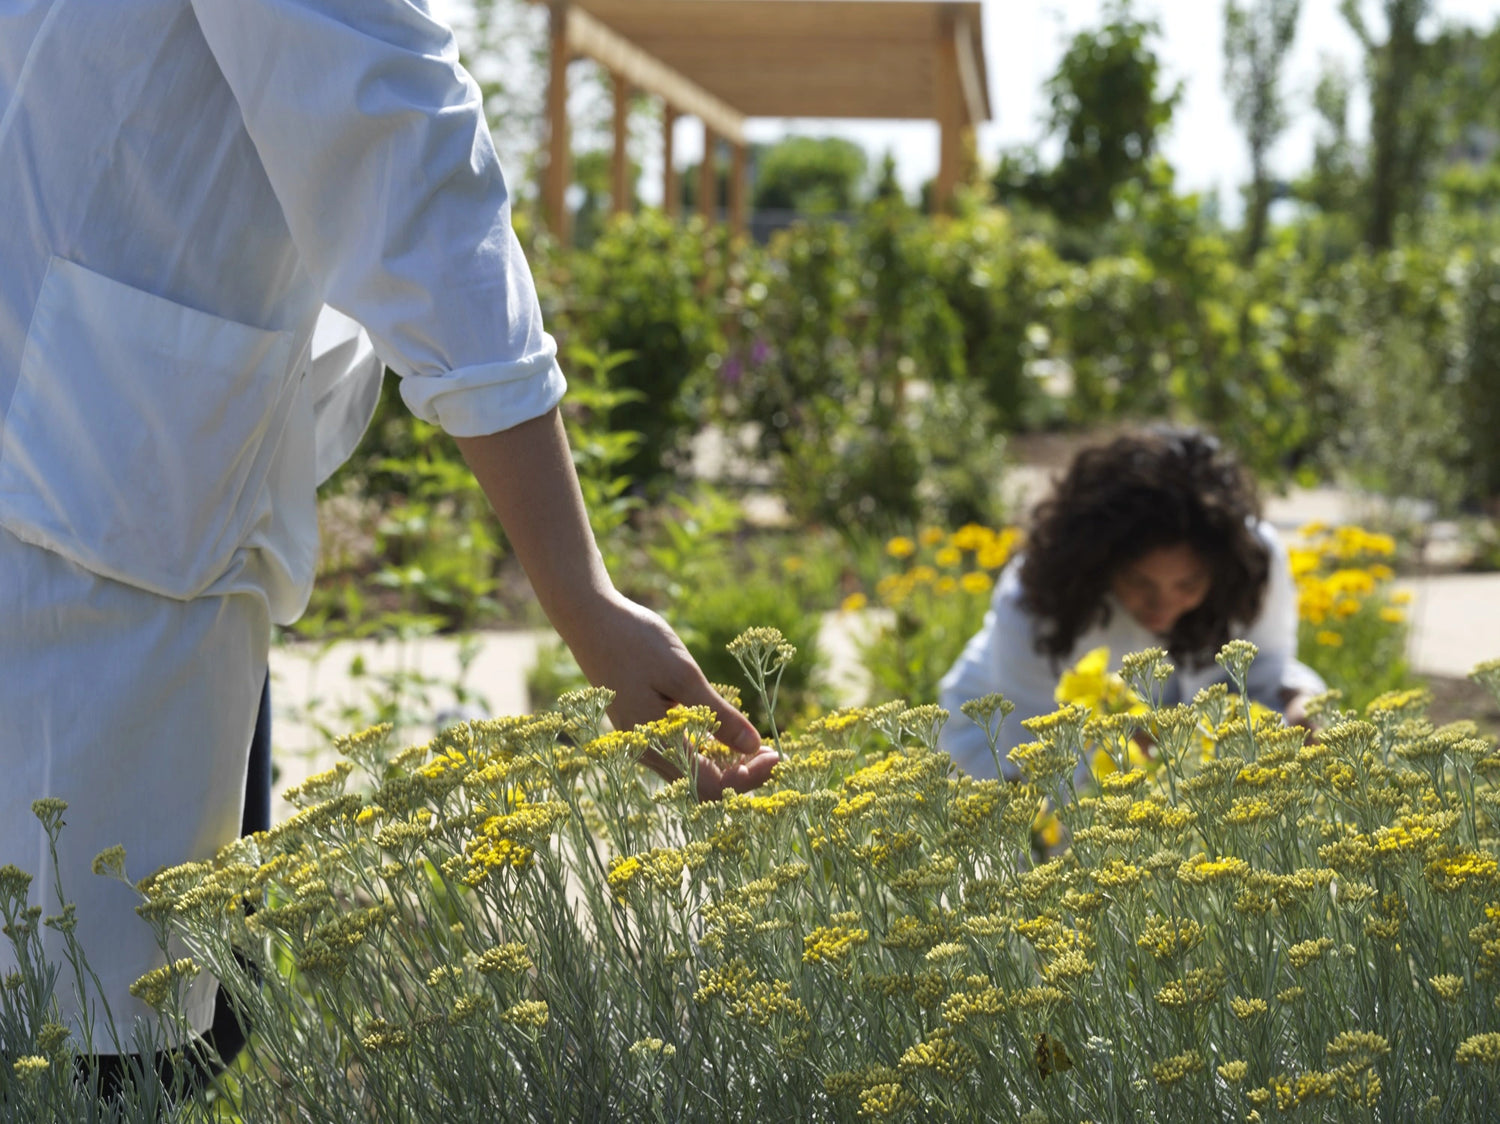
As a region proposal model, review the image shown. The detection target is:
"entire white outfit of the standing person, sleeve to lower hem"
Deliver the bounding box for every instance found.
[0,0,564,1047]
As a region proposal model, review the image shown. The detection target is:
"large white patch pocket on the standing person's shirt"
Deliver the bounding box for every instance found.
[0,258,293,599]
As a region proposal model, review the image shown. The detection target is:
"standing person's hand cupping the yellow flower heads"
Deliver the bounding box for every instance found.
[564,591,780,800]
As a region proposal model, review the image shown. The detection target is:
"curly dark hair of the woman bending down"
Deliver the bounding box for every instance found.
[1020,426,1271,666]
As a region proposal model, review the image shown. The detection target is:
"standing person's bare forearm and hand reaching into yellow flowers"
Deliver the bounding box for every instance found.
[458,408,777,798]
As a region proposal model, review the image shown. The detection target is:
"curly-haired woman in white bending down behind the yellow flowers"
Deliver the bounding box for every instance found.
[939,426,1325,779]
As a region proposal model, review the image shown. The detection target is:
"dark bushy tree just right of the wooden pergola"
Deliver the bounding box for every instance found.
[1046,0,1182,225]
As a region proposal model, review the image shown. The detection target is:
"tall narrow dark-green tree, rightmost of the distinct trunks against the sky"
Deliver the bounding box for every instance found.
[1338,0,1437,251]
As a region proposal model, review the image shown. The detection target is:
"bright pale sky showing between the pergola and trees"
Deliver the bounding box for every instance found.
[434,0,1500,216]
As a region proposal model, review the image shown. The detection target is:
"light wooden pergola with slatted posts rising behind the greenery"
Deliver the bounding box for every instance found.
[537,0,990,237]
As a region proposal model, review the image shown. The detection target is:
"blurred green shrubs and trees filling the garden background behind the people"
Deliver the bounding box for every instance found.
[300,0,1500,714]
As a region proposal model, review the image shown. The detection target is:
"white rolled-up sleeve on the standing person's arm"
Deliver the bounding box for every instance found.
[192,0,564,437]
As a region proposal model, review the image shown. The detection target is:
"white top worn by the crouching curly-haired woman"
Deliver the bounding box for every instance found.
[939,522,1325,779]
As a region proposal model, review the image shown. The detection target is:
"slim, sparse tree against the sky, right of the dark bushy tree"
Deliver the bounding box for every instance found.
[1224,0,1302,261]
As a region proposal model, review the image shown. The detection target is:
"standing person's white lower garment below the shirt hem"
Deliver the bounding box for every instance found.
[0,528,270,1052]
